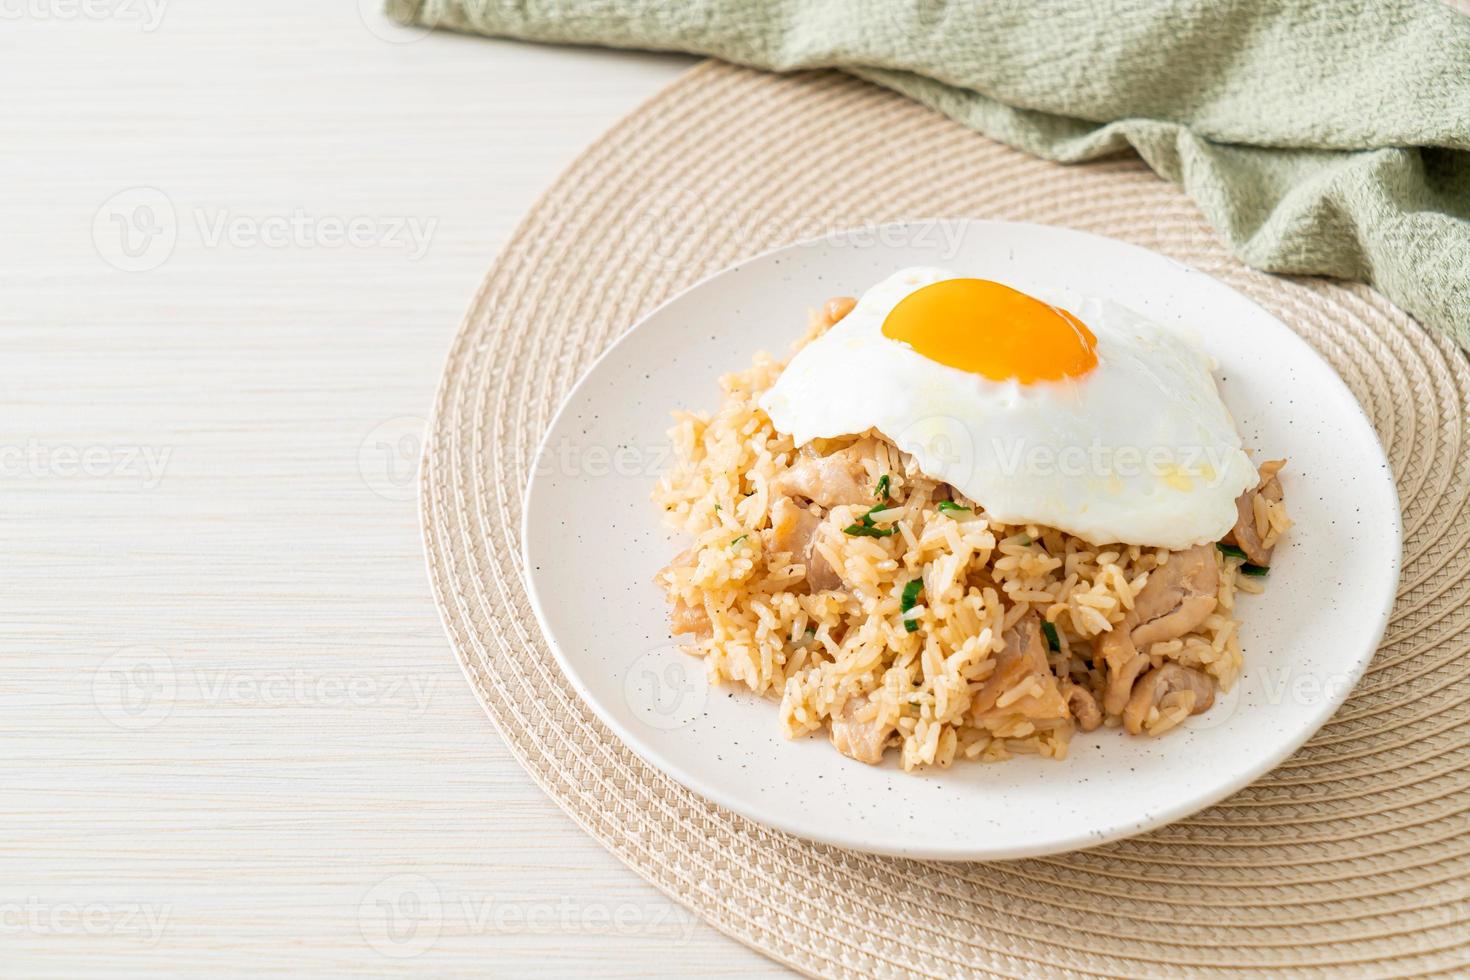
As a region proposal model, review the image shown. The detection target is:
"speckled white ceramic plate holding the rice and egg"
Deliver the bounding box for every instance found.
[523,222,1399,860]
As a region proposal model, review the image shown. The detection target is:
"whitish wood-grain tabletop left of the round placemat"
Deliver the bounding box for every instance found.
[0,0,781,977]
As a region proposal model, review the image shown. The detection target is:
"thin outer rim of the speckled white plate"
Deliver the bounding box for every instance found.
[519,216,1404,861]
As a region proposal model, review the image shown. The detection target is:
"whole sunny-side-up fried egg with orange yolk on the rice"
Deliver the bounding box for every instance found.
[760,267,1257,550]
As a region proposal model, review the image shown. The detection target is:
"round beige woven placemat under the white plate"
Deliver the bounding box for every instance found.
[422,63,1470,977]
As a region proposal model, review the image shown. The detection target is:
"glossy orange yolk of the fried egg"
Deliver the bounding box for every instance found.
[883,279,1098,385]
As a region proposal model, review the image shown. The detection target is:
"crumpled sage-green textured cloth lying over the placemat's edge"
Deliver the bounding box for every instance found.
[388,0,1470,345]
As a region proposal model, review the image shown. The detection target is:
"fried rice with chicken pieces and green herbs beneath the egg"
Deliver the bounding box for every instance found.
[654,304,1291,770]
